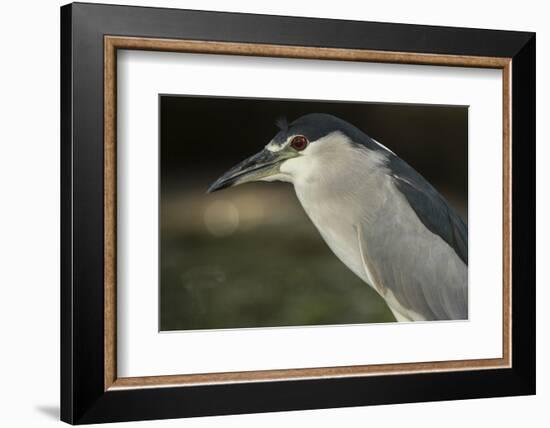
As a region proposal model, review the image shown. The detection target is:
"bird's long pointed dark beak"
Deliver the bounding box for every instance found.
[208,149,285,193]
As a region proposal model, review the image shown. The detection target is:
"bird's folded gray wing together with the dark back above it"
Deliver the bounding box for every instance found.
[359,155,468,320]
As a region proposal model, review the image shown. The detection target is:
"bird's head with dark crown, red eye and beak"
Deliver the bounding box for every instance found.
[208,113,387,193]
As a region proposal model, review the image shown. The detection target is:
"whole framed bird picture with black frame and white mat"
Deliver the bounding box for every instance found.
[61,3,535,424]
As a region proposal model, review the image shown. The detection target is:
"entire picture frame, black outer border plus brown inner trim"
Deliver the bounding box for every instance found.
[62,4,534,423]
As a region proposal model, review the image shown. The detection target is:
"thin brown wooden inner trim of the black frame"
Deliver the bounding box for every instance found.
[104,36,512,390]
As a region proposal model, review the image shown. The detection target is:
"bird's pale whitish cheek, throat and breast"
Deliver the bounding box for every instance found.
[281,133,391,285]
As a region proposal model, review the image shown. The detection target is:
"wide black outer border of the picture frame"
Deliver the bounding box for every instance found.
[61,3,536,424]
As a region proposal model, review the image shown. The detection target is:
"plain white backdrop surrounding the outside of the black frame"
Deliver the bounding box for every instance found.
[0,0,550,428]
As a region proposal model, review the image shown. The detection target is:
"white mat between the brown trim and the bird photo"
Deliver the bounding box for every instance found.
[117,51,502,377]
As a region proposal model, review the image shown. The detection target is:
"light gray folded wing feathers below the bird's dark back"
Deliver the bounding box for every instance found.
[360,188,468,320]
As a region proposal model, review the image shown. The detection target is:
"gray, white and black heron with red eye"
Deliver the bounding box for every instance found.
[207,113,468,322]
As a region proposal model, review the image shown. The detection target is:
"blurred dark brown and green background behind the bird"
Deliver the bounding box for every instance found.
[160,95,468,331]
